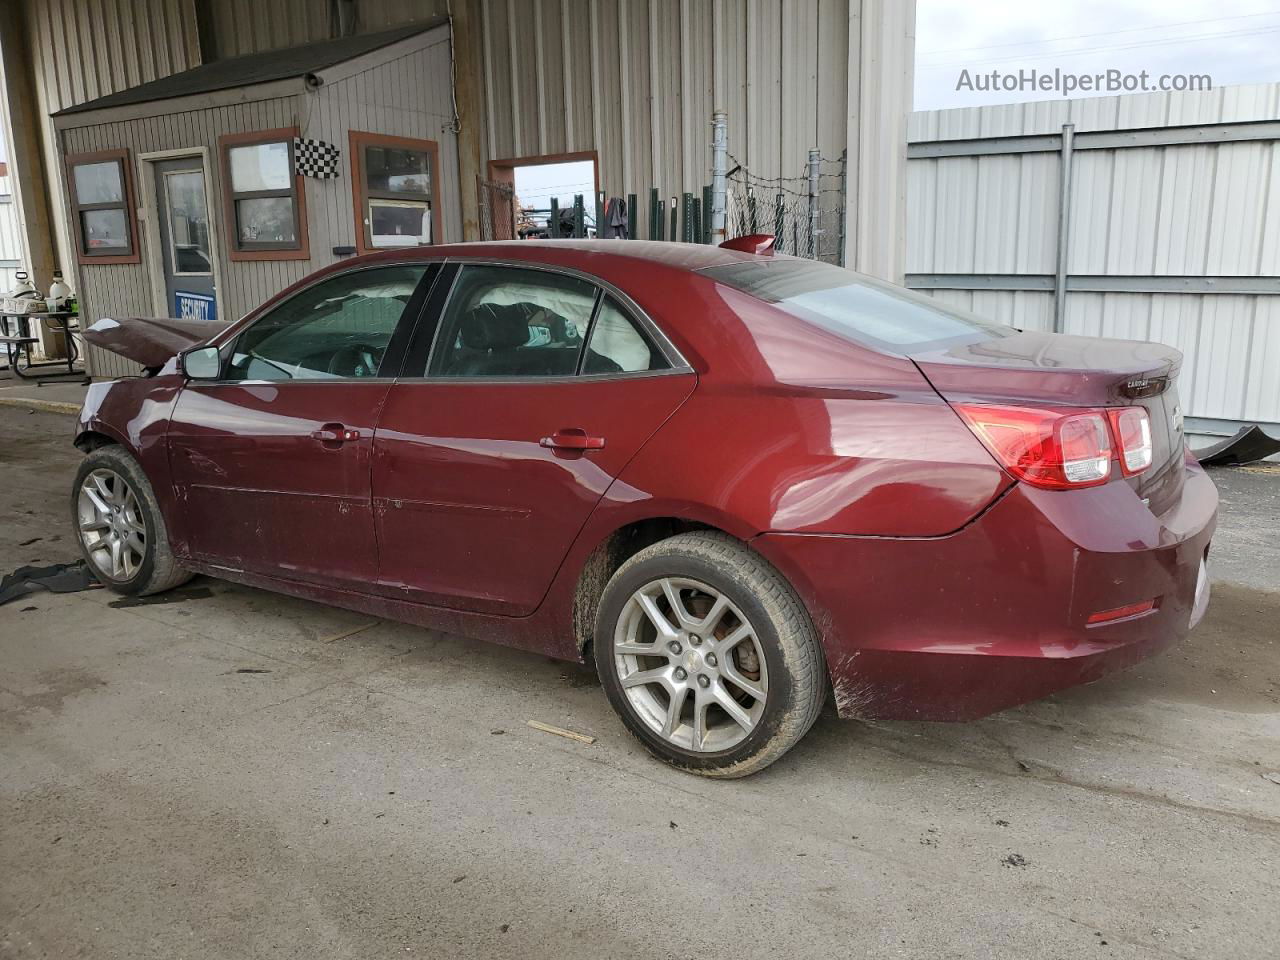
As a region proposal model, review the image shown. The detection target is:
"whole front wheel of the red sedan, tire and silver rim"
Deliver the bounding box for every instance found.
[72,445,192,596]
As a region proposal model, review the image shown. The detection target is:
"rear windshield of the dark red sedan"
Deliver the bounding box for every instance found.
[703,257,1016,353]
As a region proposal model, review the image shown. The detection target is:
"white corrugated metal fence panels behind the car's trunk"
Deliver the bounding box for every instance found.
[906,83,1280,430]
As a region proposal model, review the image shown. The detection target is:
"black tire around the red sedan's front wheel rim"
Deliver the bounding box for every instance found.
[70,444,195,596]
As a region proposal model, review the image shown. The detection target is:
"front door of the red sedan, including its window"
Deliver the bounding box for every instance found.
[169,264,436,591]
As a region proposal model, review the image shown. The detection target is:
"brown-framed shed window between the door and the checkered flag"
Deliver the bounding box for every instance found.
[218,128,310,260]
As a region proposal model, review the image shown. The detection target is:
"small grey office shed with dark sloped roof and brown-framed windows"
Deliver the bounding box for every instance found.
[54,23,462,376]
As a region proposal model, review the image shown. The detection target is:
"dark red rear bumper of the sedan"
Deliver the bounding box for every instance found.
[755,462,1217,721]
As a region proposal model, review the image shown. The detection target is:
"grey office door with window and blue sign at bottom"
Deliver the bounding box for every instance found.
[155,155,218,320]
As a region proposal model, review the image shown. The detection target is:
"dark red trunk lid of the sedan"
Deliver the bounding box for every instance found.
[909,330,1184,513]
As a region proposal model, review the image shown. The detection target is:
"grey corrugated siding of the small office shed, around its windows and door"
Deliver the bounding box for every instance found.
[64,27,461,376]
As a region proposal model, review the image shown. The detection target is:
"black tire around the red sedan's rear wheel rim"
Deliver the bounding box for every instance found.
[593,531,827,778]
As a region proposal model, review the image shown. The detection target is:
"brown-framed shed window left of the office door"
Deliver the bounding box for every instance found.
[67,150,141,264]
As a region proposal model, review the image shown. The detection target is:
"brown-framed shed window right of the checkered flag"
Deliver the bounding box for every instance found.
[351,131,440,253]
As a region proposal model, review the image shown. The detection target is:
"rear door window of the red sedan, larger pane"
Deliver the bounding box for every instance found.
[428,264,596,378]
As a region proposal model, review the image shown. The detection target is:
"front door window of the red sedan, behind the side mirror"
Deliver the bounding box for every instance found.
[224,265,426,380]
